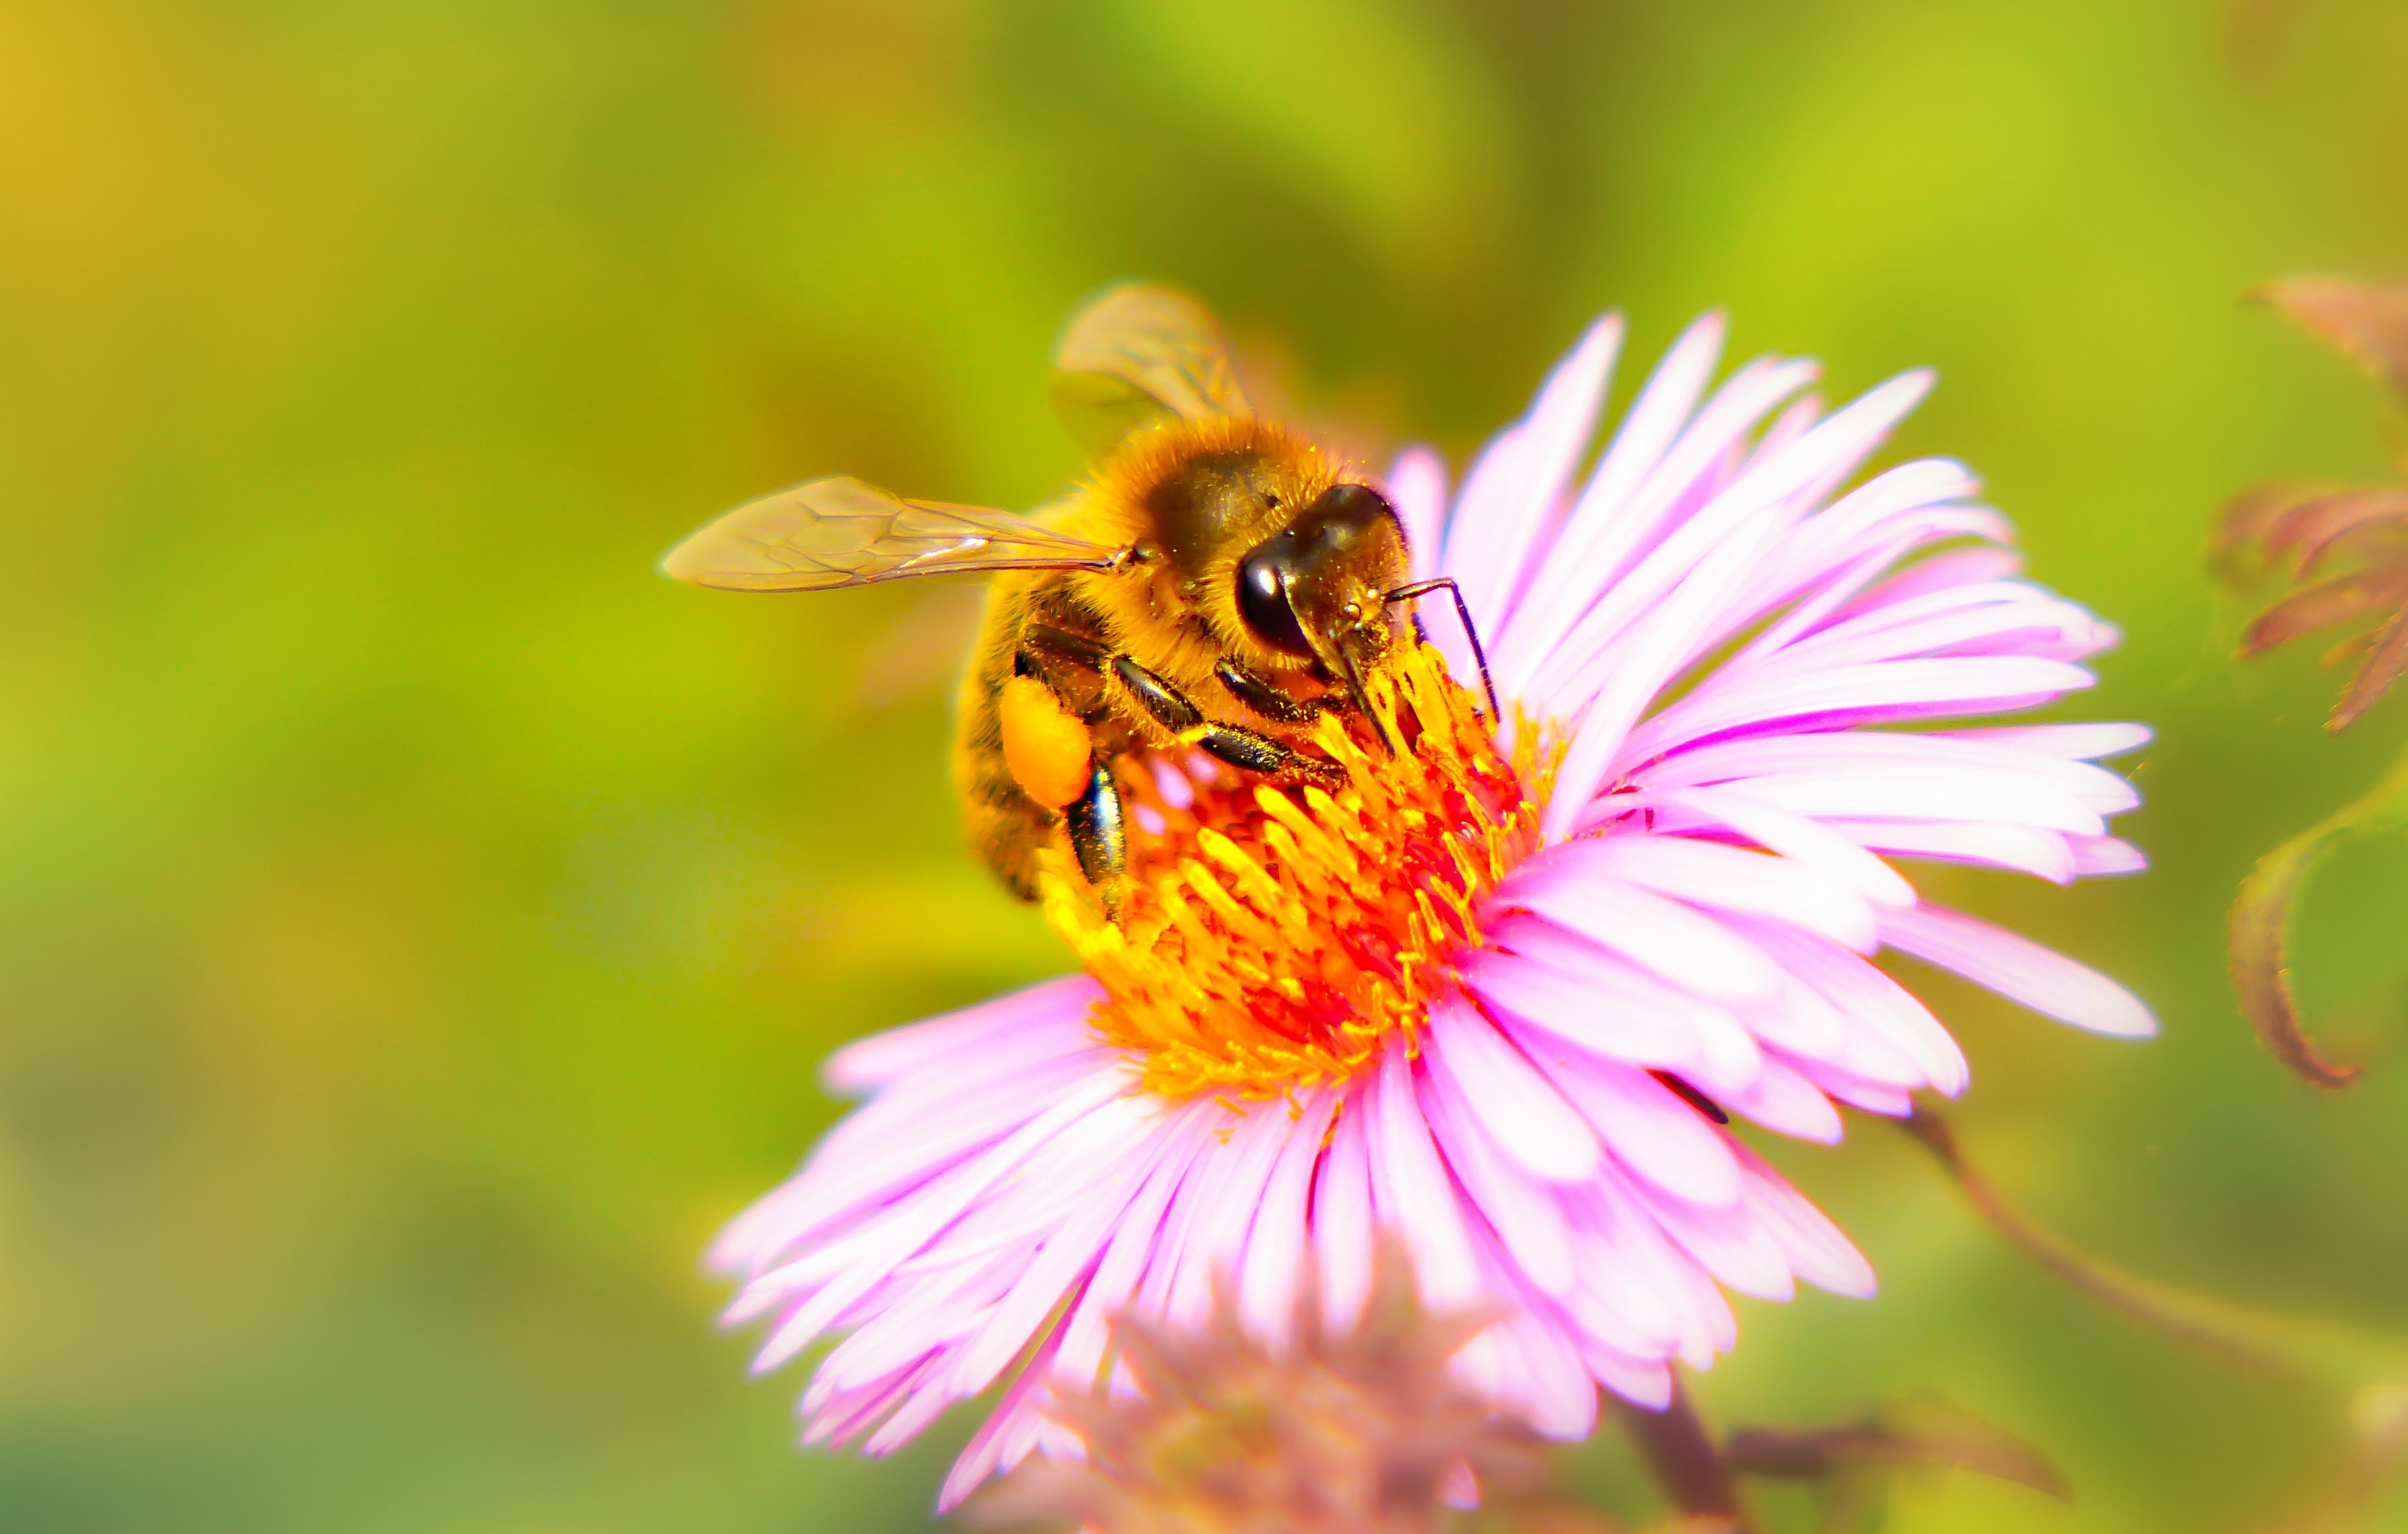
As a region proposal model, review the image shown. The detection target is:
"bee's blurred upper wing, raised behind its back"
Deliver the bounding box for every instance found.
[1052,282,1252,453]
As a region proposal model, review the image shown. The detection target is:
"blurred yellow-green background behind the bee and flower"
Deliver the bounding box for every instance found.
[0,0,2408,1534]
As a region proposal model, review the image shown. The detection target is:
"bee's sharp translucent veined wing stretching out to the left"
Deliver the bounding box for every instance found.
[660,477,1119,592]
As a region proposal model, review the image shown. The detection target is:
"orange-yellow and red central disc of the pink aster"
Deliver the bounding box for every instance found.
[1040,645,1558,1101]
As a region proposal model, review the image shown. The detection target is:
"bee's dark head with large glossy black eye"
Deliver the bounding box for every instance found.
[1238,484,1406,730]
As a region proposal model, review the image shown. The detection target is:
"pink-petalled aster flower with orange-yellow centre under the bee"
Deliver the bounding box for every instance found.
[713,315,2153,1505]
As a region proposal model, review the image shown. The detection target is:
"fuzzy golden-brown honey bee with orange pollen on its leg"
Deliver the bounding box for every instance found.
[660,284,1495,915]
